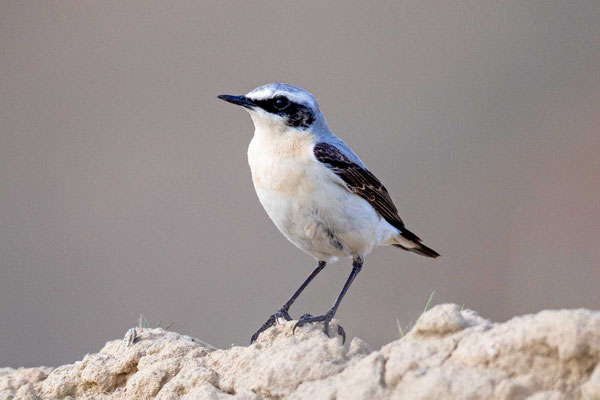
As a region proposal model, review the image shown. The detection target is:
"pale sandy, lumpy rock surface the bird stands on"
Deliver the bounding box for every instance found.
[0,304,600,400]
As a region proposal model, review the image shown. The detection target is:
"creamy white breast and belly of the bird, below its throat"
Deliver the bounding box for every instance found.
[248,129,397,261]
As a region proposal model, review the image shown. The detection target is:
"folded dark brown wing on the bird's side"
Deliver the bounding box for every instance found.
[313,143,410,234]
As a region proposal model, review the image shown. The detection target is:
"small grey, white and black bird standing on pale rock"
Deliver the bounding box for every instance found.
[217,83,439,344]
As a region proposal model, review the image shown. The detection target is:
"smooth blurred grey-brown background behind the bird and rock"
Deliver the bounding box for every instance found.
[0,1,600,367]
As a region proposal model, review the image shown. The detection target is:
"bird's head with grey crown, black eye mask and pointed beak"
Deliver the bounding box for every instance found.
[217,83,326,131]
